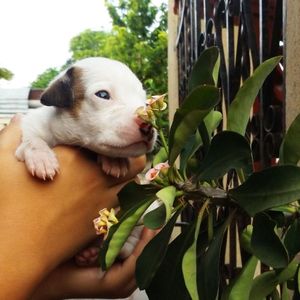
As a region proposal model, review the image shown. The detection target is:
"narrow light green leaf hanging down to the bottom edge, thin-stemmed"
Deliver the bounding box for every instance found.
[182,202,208,300]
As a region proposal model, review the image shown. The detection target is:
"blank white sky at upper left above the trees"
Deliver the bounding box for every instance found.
[0,0,111,88]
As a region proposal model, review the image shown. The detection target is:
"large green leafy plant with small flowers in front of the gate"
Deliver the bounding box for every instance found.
[100,47,300,300]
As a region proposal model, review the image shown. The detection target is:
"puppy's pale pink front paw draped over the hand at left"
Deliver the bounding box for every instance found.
[16,144,59,180]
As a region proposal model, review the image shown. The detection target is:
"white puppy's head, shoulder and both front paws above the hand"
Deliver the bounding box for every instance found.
[16,57,156,180]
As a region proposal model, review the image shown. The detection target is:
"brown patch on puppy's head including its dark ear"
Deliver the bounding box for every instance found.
[41,67,84,110]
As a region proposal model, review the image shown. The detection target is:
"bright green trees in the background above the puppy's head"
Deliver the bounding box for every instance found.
[32,0,167,94]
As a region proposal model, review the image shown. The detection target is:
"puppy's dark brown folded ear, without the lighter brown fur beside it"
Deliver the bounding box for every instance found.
[41,67,75,108]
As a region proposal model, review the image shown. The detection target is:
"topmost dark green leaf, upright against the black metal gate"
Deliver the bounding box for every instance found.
[188,47,219,91]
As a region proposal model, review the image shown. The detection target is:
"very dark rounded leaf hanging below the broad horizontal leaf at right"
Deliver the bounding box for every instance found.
[251,213,289,269]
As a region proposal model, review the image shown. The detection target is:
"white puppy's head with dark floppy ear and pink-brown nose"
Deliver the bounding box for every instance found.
[41,57,156,157]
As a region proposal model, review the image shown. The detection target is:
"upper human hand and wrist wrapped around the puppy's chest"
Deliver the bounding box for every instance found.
[0,113,145,300]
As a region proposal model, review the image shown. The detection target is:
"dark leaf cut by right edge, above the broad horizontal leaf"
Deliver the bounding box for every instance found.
[279,115,300,165]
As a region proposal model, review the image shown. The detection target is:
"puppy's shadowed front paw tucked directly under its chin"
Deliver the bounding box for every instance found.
[100,156,129,178]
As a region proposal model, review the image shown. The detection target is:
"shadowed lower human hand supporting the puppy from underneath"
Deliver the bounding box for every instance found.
[31,228,156,300]
